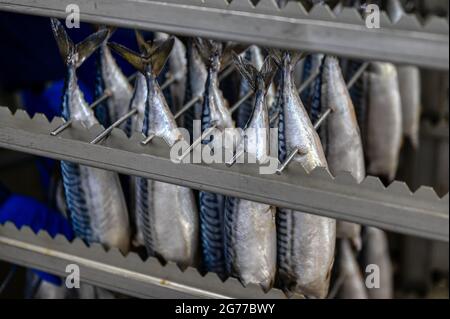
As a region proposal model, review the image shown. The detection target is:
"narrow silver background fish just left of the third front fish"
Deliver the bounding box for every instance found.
[188,40,208,120]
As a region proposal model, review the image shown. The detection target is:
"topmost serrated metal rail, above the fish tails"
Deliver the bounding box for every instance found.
[0,0,449,70]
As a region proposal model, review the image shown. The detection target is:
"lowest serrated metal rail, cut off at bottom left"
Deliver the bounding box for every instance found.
[0,223,286,299]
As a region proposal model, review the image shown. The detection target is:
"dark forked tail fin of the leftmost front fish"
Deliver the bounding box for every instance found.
[51,18,109,68]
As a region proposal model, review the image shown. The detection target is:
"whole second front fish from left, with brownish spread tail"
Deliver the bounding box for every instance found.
[109,38,198,268]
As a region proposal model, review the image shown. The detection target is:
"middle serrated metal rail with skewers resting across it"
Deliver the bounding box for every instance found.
[0,107,449,242]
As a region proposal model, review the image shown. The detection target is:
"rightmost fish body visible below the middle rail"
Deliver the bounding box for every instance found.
[363,227,394,299]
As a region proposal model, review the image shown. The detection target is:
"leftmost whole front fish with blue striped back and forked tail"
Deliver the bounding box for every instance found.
[51,19,130,252]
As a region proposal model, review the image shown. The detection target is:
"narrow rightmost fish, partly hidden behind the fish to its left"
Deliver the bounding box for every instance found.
[397,66,421,148]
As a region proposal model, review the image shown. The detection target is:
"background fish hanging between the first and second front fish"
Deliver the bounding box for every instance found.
[95,29,133,128]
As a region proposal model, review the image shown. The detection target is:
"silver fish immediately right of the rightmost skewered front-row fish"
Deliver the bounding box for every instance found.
[322,56,366,250]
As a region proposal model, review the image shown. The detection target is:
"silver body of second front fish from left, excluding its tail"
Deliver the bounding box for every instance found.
[136,69,199,267]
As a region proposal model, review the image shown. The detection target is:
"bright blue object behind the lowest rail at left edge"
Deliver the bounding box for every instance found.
[0,195,74,286]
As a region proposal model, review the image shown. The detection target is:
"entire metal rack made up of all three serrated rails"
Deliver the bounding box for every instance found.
[0,0,449,298]
